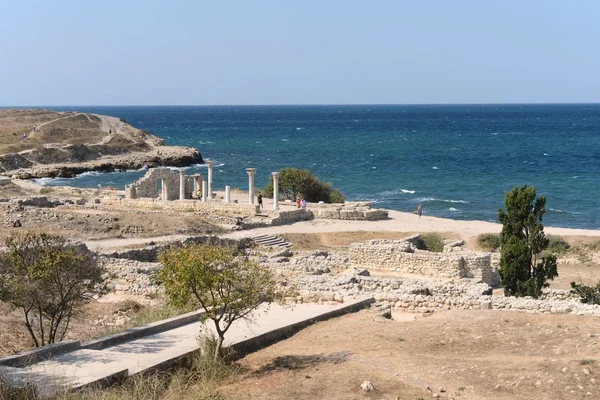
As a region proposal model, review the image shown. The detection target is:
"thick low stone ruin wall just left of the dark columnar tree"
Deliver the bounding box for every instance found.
[349,240,498,285]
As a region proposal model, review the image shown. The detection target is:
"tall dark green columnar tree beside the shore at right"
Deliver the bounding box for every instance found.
[498,186,558,298]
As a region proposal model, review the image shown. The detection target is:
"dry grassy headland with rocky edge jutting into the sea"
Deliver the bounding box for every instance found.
[0,109,203,179]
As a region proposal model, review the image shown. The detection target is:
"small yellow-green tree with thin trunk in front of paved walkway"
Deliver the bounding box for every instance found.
[156,244,285,360]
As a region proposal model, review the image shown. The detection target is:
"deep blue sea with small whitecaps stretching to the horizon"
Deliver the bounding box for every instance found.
[36,104,600,229]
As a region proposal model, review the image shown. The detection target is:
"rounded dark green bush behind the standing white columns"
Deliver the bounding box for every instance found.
[264,168,344,203]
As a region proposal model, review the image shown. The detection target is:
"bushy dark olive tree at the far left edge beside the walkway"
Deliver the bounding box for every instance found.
[0,233,104,347]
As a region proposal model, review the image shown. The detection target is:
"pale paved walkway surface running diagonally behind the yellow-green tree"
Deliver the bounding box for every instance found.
[0,304,366,393]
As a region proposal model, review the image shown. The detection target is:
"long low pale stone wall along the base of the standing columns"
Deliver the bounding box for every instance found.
[100,196,257,215]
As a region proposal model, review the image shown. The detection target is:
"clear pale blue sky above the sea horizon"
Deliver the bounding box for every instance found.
[0,0,600,106]
